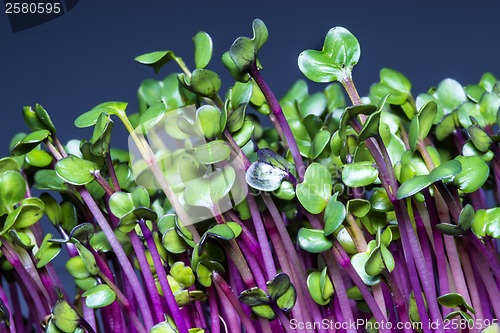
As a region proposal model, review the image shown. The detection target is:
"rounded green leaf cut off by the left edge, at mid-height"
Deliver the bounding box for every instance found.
[0,170,26,215]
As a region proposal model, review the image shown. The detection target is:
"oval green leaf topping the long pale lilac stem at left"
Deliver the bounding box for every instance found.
[55,155,99,185]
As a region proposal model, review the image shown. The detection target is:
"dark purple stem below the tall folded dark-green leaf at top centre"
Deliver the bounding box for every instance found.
[248,62,306,182]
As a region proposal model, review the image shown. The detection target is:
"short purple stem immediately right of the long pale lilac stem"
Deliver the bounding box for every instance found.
[129,230,165,323]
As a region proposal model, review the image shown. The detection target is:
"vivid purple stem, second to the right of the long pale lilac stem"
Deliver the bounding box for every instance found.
[139,219,188,333]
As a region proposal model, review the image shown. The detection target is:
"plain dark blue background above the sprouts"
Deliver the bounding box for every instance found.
[0,0,500,155]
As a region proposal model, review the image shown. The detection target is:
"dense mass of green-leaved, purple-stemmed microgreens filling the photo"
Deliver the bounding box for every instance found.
[0,19,500,333]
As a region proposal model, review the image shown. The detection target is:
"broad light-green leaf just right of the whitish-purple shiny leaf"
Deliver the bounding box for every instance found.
[297,163,332,214]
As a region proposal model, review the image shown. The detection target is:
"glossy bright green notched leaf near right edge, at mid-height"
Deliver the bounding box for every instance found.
[453,156,490,193]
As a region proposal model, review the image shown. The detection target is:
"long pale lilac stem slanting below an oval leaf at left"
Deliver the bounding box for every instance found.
[78,187,154,333]
